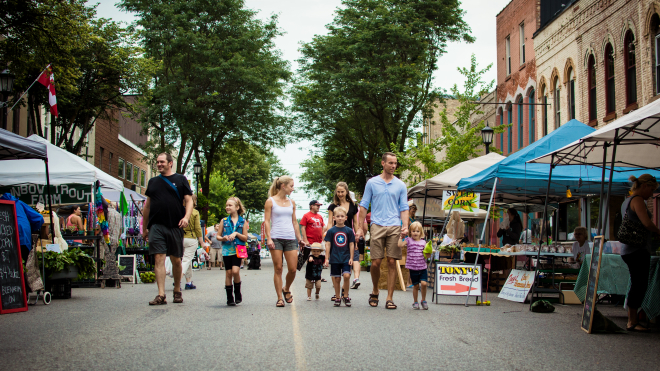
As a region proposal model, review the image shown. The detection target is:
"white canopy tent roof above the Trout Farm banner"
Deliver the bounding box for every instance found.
[0,135,124,191]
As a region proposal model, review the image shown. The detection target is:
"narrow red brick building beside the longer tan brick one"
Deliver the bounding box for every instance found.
[494,0,540,155]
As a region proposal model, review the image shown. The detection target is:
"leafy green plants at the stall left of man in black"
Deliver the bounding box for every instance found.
[37,248,96,280]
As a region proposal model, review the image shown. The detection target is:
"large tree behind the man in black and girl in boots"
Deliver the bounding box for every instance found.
[119,0,290,221]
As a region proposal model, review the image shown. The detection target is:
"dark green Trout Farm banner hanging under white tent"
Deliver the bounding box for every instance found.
[0,183,93,205]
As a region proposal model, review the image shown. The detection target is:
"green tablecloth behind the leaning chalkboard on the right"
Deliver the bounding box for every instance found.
[573,254,630,302]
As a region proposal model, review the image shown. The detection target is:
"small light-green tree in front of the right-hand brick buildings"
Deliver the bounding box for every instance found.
[392,54,510,181]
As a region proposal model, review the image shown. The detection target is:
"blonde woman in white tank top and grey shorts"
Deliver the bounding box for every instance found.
[264,175,303,307]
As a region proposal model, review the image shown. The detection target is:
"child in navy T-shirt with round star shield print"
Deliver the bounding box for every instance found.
[324,206,355,307]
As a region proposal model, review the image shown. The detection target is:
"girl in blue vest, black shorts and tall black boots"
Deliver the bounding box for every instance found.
[216,197,249,306]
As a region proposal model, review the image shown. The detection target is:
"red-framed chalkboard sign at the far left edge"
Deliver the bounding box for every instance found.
[0,200,27,314]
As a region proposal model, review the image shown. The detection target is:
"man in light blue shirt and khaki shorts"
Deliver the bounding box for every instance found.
[356,152,409,309]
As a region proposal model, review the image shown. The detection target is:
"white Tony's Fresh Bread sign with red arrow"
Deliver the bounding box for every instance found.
[435,263,481,296]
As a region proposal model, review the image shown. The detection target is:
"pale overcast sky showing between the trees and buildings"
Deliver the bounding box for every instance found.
[90,0,509,221]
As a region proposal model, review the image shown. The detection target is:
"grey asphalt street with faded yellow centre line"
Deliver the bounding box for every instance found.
[0,259,660,370]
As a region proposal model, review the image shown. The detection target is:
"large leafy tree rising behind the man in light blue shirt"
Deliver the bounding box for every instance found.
[292,0,472,196]
